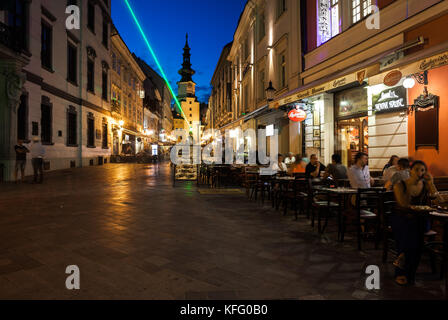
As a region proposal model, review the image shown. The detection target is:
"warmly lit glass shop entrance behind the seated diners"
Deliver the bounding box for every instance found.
[336,117,369,167]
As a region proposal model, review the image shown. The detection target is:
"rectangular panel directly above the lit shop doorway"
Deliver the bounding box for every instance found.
[334,87,367,118]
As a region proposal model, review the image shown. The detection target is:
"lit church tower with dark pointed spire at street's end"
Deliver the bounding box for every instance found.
[177,33,200,130]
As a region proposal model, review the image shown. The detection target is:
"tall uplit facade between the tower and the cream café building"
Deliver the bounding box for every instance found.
[210,0,301,158]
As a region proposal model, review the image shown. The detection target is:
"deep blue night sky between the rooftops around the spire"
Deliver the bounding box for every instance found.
[112,0,246,102]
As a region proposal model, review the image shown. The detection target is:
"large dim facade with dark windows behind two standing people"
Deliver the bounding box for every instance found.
[0,0,117,180]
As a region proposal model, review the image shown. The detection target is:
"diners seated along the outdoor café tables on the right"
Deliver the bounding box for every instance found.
[272,152,446,285]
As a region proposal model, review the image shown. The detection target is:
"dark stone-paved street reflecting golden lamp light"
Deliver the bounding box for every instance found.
[0,164,443,299]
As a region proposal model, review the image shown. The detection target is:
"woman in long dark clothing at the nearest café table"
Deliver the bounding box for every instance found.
[390,161,443,285]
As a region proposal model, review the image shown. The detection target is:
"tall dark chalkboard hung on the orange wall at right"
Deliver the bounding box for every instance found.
[414,94,439,150]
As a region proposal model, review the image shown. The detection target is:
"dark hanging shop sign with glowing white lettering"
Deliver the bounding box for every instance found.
[372,86,406,113]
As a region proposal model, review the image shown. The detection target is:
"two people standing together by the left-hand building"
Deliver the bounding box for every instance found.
[14,137,45,183]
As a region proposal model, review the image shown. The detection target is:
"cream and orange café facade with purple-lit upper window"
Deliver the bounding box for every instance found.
[271,0,448,175]
